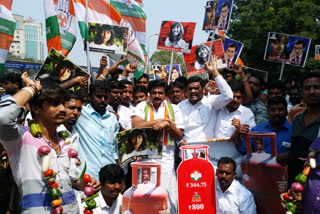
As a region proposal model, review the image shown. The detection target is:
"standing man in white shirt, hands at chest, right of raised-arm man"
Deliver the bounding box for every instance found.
[214,80,256,181]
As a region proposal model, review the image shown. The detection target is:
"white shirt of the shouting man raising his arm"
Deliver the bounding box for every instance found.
[178,75,233,142]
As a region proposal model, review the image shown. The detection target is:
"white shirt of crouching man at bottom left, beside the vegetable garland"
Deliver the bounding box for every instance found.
[78,192,122,214]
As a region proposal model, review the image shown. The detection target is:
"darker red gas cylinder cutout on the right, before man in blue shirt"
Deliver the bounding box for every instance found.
[241,132,288,214]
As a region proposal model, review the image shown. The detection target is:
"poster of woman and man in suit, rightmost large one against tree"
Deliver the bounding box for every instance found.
[264,32,311,67]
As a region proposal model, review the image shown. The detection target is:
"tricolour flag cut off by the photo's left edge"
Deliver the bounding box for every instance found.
[0,0,16,76]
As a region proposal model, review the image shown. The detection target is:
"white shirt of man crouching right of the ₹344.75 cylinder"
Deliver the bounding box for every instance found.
[216,179,257,214]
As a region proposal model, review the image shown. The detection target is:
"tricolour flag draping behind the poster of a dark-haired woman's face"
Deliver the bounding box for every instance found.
[74,0,145,78]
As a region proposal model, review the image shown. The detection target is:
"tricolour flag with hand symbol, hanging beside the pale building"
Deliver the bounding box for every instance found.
[44,0,77,56]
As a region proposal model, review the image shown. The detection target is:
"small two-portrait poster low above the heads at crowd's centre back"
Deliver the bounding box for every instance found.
[152,65,182,79]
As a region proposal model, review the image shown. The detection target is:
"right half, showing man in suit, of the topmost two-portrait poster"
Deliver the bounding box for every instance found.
[213,0,233,30]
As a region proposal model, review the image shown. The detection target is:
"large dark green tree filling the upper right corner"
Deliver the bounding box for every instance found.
[228,0,320,79]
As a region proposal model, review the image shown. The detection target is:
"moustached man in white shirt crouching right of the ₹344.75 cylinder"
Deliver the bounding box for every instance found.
[215,157,257,214]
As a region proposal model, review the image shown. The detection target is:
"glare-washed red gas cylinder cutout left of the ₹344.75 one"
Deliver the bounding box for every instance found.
[122,162,169,214]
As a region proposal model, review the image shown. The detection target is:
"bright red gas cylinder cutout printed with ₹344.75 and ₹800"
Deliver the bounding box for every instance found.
[177,145,216,214]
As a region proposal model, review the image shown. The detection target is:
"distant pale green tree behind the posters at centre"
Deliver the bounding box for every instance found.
[150,50,186,75]
